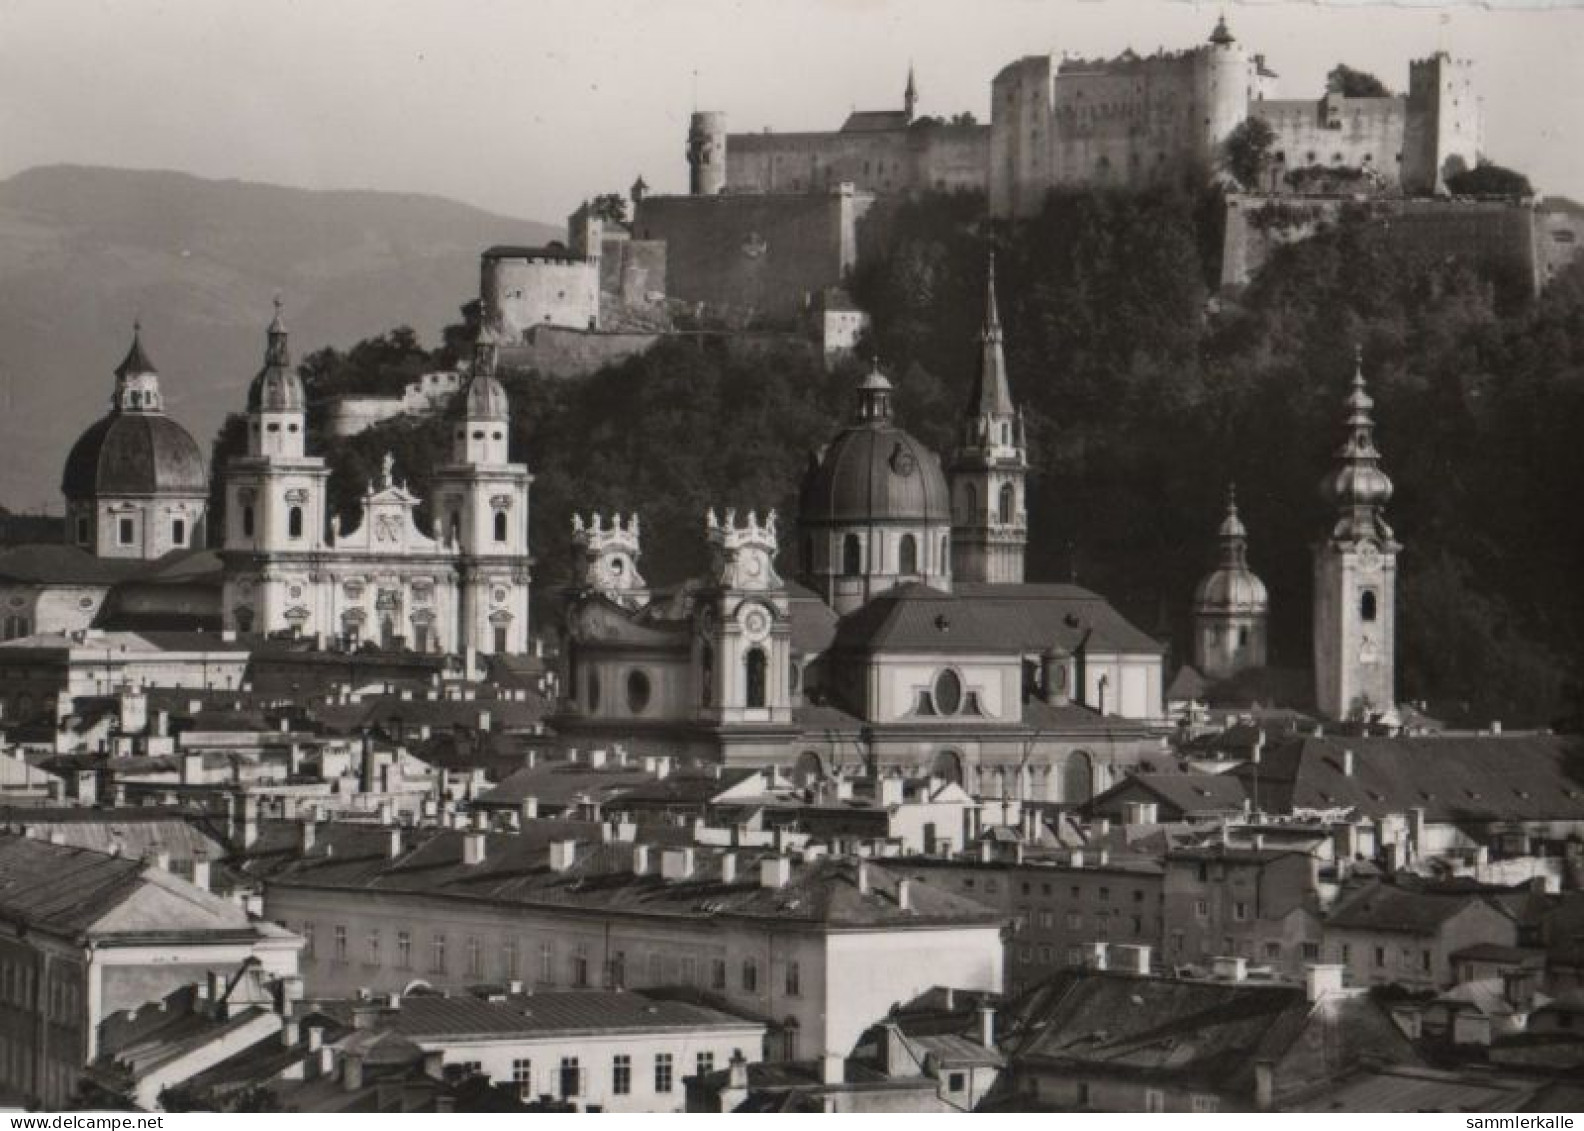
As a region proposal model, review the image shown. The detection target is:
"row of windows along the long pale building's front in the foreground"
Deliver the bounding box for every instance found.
[299,922,803,998]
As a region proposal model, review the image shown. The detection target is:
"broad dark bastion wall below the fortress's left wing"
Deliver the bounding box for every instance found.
[634,193,874,317]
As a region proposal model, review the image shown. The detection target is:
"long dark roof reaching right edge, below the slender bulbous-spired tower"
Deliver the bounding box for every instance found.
[1232,735,1584,822]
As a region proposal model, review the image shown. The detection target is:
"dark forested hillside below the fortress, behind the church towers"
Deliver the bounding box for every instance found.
[234,190,1584,725]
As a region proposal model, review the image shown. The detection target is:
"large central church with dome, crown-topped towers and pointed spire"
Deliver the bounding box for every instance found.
[554,265,1164,802]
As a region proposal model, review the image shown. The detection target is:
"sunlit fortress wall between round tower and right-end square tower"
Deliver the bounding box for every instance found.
[1248,97,1408,189]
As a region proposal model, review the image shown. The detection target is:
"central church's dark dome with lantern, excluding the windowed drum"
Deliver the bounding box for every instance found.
[800,369,952,524]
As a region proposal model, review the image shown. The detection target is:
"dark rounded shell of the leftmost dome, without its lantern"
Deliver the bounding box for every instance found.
[60,412,209,499]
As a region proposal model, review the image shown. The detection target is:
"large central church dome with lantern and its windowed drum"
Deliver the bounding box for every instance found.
[798,363,952,613]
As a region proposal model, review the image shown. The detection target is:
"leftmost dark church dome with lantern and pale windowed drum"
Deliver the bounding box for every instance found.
[60,323,209,561]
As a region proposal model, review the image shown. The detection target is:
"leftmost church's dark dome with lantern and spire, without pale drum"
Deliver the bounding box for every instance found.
[60,333,209,499]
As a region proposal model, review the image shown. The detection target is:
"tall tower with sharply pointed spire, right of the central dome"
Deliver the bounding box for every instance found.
[947,253,1028,583]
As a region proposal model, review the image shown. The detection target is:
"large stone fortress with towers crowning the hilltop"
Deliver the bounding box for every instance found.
[687,19,1481,217]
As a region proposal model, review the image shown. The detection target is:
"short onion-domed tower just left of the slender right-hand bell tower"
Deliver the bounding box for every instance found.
[1193,485,1270,680]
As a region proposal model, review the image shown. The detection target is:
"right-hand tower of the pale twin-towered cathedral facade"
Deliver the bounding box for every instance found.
[431,316,532,654]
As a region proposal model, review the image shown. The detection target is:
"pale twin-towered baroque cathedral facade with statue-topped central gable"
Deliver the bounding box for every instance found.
[222,309,532,654]
